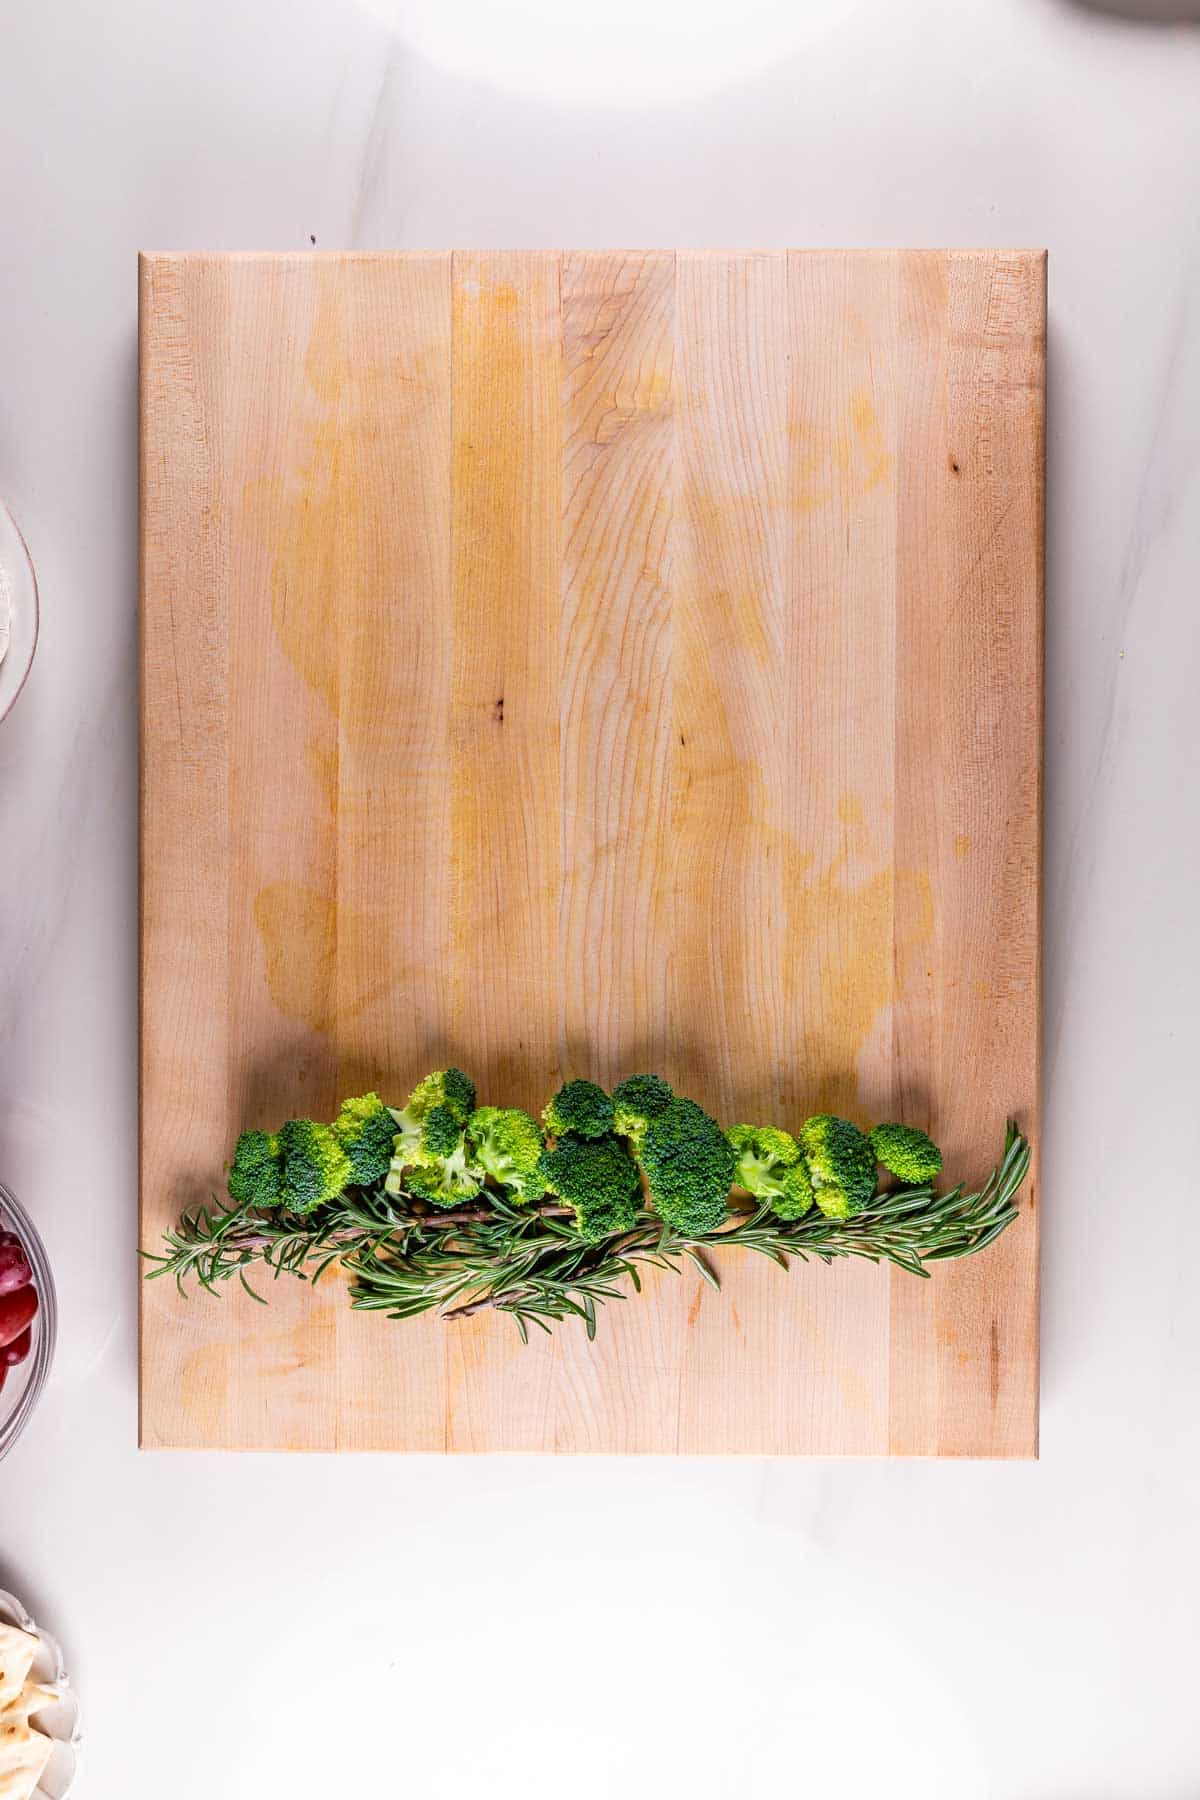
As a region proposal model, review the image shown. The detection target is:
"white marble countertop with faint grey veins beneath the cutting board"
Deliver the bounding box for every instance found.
[0,0,1200,1800]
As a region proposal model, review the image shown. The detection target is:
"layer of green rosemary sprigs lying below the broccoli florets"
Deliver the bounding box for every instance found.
[144,1125,1031,1343]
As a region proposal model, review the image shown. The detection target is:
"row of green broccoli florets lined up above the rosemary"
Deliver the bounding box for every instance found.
[228,1069,941,1240]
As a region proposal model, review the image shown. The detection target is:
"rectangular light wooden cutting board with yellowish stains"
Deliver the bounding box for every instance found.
[140,252,1045,1456]
